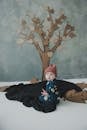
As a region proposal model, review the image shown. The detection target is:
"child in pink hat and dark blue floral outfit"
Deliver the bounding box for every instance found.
[39,65,58,102]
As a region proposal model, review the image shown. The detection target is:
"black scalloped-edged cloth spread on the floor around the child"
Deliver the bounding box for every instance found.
[5,79,82,112]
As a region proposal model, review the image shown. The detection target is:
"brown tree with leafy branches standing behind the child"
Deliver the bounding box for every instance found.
[19,6,76,80]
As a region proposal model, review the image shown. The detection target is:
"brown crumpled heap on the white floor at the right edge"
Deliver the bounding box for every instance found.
[65,90,87,103]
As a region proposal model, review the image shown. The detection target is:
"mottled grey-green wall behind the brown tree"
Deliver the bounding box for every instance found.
[0,0,87,81]
